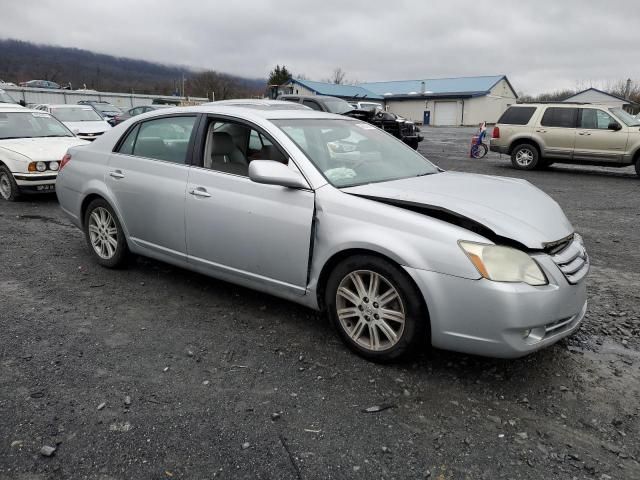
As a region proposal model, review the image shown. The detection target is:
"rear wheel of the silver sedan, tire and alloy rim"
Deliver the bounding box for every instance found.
[84,198,129,268]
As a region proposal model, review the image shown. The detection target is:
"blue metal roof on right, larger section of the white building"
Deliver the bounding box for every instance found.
[360,75,515,98]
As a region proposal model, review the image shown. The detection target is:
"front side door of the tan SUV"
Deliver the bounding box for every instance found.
[574,107,629,163]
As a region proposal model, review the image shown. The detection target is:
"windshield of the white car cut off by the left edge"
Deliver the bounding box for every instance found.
[0,112,73,140]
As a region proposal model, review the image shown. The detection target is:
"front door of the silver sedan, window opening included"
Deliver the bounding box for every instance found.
[186,117,314,295]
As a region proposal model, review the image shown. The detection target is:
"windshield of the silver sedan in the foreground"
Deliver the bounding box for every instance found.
[273,119,438,188]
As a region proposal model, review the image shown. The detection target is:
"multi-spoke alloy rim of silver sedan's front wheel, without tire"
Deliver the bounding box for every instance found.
[336,270,406,352]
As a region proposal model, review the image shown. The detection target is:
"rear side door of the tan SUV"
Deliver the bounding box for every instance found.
[534,107,578,159]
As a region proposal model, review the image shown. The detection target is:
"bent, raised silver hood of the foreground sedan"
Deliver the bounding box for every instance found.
[342,172,573,249]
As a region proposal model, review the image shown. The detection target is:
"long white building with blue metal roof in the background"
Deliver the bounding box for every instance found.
[282,75,518,126]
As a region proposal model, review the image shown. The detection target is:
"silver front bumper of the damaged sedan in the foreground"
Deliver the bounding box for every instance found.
[405,255,587,358]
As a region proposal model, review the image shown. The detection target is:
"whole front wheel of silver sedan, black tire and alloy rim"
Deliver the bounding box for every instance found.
[325,255,428,362]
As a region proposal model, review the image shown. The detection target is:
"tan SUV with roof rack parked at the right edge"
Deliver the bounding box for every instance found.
[490,102,640,175]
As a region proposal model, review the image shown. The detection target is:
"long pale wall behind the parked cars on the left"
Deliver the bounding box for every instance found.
[2,86,208,109]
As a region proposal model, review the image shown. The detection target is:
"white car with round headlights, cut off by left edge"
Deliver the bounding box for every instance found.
[0,104,87,201]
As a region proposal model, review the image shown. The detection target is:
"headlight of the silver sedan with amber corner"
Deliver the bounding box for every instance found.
[458,241,549,285]
